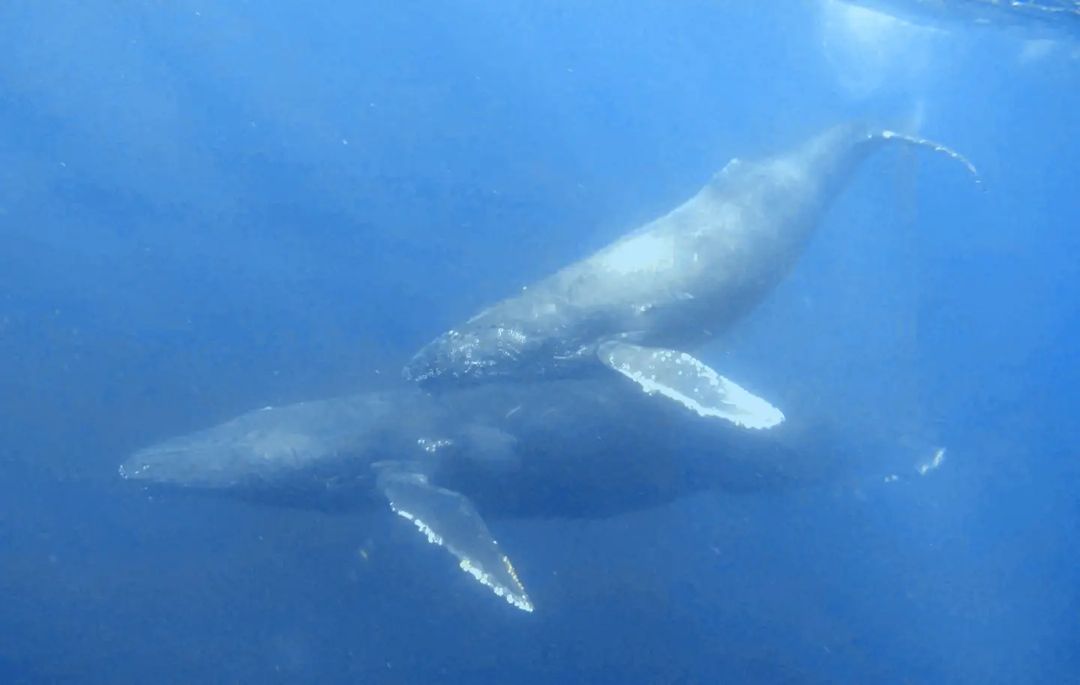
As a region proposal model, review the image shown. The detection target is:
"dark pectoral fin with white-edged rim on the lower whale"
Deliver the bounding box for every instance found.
[377,462,532,612]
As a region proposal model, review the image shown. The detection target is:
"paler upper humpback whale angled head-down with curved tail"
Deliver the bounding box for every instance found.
[404,119,975,428]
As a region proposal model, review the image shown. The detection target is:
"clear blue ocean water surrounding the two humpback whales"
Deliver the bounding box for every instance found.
[0,0,1080,683]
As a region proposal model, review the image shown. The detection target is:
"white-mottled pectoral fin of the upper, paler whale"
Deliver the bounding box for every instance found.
[598,343,784,428]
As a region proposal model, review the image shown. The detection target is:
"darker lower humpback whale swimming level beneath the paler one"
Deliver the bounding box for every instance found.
[120,376,868,612]
